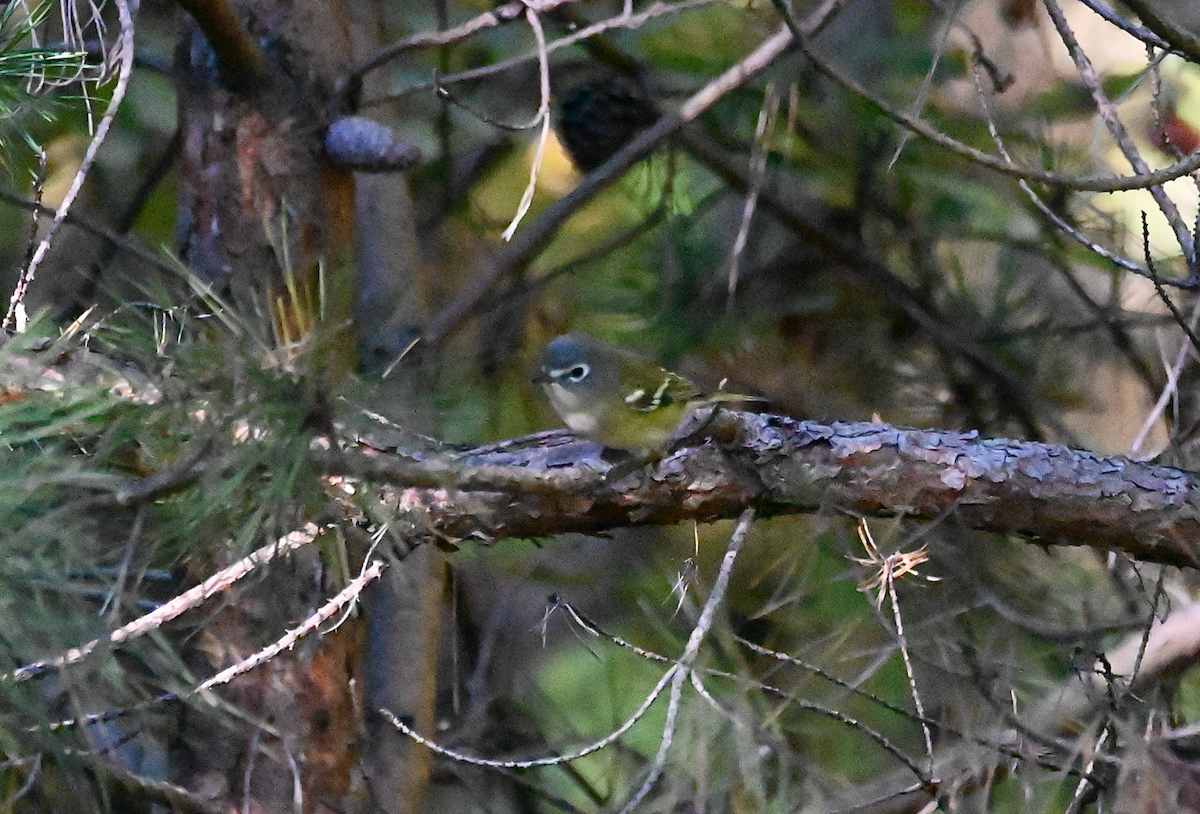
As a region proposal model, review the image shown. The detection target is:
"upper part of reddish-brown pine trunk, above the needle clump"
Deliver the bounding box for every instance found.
[176,0,356,367]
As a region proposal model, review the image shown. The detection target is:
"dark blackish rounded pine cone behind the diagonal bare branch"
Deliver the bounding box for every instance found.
[557,77,661,173]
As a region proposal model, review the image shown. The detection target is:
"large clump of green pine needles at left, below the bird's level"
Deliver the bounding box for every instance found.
[0,301,343,810]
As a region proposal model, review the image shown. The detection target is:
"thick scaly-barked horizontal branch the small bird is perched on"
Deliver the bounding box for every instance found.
[331,411,1200,565]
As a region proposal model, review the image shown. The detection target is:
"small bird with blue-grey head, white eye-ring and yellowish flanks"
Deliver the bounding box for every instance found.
[533,334,749,455]
